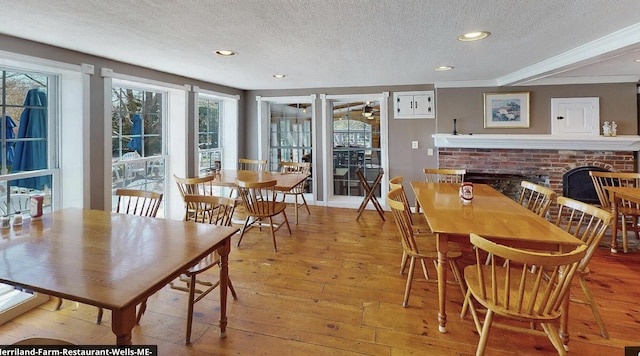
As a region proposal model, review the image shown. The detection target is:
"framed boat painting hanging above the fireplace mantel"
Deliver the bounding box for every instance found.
[484,92,529,129]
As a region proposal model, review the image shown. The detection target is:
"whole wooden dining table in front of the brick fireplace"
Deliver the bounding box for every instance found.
[411,182,582,345]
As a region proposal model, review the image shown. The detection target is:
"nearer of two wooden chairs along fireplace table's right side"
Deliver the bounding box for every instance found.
[555,197,613,339]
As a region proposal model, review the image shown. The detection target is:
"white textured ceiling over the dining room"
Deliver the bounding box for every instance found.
[0,0,640,89]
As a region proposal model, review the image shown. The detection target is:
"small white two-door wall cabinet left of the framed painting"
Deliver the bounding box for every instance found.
[393,90,436,119]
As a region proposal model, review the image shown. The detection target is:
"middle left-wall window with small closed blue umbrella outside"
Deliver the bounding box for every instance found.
[111,86,166,216]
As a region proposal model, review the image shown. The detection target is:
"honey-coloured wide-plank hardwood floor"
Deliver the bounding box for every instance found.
[0,206,640,355]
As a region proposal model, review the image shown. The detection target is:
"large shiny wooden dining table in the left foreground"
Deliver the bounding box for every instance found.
[0,208,238,345]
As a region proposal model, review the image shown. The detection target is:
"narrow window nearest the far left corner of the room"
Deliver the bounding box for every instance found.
[198,95,224,173]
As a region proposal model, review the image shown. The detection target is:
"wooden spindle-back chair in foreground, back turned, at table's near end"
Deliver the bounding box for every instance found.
[464,234,587,355]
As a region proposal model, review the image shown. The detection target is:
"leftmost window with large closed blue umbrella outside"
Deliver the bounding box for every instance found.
[0,68,57,216]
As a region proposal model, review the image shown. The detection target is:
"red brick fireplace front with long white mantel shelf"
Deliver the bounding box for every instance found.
[434,134,640,214]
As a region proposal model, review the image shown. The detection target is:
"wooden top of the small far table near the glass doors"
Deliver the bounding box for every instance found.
[202,169,309,191]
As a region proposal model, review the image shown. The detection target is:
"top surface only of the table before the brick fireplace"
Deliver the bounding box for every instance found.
[411,182,582,246]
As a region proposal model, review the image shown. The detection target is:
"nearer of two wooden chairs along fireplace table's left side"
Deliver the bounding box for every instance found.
[387,188,466,308]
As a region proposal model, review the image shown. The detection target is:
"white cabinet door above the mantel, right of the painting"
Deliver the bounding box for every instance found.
[551,98,600,136]
